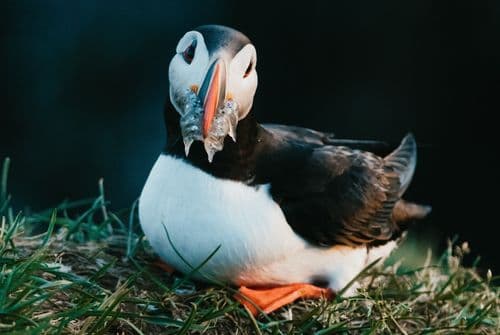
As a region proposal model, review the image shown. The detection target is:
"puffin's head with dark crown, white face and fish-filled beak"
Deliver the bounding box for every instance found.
[169,25,257,162]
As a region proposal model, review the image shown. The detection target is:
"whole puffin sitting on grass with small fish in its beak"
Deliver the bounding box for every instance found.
[138,25,431,314]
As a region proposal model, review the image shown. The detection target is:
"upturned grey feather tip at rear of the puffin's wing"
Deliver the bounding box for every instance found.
[384,133,417,197]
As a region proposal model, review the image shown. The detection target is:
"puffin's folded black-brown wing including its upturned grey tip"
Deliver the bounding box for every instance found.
[266,128,416,246]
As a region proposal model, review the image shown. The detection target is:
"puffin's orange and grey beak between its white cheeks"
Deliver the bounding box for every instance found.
[198,59,226,138]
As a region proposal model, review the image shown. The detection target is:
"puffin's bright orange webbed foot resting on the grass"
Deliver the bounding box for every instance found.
[235,284,333,316]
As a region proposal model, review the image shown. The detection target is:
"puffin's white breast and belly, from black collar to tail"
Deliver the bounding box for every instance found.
[139,155,395,290]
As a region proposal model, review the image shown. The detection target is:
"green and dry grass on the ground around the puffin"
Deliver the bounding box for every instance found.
[0,160,500,335]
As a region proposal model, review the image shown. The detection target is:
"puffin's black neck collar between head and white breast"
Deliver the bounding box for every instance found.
[164,102,262,182]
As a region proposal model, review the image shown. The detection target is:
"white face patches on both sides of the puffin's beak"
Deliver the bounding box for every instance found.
[169,31,257,120]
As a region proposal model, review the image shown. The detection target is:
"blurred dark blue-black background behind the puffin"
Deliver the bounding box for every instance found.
[0,0,500,269]
